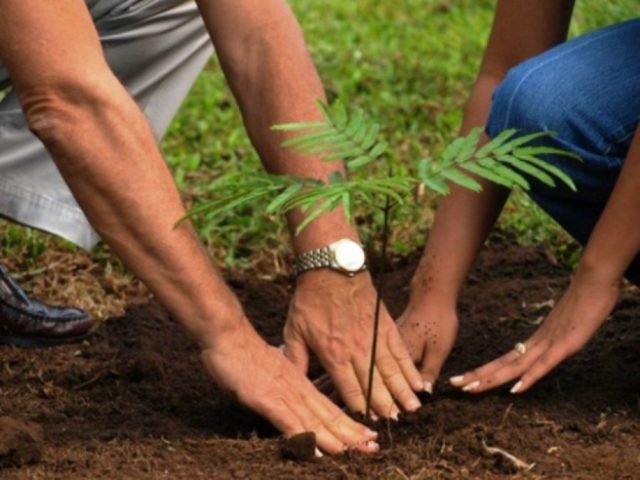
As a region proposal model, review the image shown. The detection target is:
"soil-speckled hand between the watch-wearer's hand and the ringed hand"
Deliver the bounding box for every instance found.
[398,303,458,393]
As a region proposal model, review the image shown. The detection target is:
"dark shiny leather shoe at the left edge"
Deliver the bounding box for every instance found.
[0,265,96,346]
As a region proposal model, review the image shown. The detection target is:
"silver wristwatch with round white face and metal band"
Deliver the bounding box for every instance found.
[296,238,367,277]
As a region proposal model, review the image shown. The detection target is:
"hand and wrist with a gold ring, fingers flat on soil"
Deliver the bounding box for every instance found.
[450,270,620,393]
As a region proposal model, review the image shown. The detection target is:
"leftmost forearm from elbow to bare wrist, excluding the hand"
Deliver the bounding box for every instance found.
[25,82,248,346]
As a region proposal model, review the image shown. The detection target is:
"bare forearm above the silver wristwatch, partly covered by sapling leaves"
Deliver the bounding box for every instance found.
[200,1,357,251]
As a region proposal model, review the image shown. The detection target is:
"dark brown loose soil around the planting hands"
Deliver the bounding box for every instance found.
[0,245,640,479]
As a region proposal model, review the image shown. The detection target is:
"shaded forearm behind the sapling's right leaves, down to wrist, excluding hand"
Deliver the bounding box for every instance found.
[412,0,573,305]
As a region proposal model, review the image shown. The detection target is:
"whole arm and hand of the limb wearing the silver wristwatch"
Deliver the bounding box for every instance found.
[198,0,423,416]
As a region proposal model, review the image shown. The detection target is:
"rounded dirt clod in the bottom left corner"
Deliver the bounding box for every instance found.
[0,417,44,468]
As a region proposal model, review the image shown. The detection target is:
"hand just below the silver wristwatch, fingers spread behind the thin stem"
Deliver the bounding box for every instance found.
[284,269,424,418]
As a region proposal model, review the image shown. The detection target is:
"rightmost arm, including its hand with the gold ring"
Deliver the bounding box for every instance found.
[452,128,640,393]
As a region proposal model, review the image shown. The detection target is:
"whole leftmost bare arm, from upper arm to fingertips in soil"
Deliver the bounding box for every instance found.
[0,0,376,452]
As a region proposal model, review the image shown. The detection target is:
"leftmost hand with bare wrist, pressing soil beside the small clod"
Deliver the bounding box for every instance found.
[201,322,379,454]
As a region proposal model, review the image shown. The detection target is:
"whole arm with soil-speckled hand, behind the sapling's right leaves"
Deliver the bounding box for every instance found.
[401,0,573,390]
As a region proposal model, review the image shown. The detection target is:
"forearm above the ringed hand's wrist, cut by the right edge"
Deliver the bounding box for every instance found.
[578,128,640,283]
